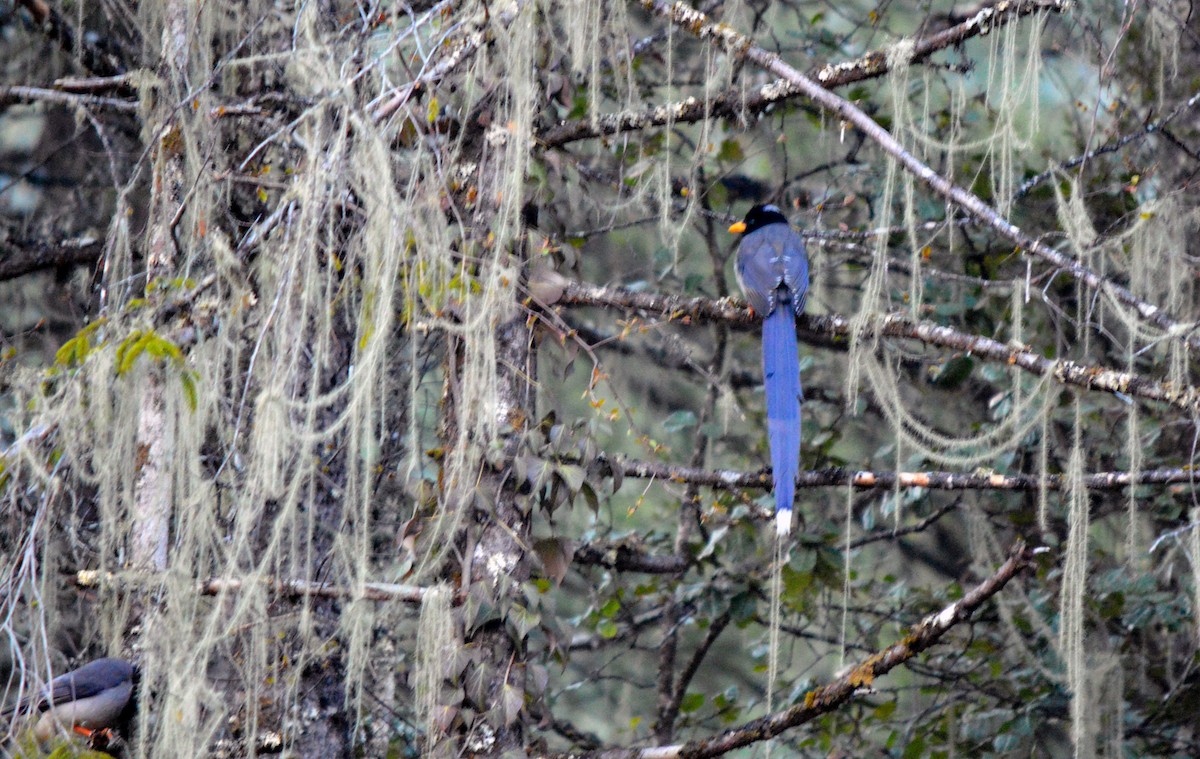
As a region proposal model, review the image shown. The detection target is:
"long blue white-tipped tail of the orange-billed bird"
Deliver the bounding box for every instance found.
[762,301,803,534]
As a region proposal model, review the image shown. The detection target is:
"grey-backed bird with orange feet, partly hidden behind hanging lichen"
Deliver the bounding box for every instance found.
[0,658,136,741]
